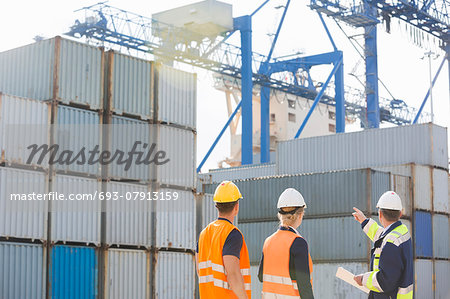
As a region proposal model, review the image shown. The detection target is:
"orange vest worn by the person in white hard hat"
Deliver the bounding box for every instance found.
[263,230,313,298]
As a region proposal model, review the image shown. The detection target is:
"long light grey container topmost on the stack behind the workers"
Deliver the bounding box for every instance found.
[277,124,448,174]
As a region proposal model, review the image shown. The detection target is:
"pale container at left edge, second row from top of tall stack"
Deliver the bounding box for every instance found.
[0,94,50,167]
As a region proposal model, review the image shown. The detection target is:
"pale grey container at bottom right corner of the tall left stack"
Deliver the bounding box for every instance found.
[154,251,197,299]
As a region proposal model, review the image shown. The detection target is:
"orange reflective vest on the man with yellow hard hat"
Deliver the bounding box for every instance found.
[198,219,251,299]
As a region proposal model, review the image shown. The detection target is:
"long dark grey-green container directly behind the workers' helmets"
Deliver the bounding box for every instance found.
[205,169,390,221]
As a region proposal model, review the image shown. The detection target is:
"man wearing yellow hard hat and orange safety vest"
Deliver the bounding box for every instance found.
[195,181,251,299]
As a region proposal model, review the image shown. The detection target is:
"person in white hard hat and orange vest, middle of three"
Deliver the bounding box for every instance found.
[258,188,314,299]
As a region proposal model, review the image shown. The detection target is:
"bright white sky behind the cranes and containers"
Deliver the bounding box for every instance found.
[0,0,450,171]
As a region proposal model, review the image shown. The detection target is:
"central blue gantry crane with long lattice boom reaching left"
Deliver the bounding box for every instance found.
[66,0,430,171]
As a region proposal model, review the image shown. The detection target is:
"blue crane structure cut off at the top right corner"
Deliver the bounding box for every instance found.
[310,0,450,128]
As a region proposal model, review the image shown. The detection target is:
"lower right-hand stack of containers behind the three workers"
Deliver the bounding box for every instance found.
[198,124,450,298]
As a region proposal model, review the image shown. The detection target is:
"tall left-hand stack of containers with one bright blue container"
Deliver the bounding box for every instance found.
[0,37,196,298]
